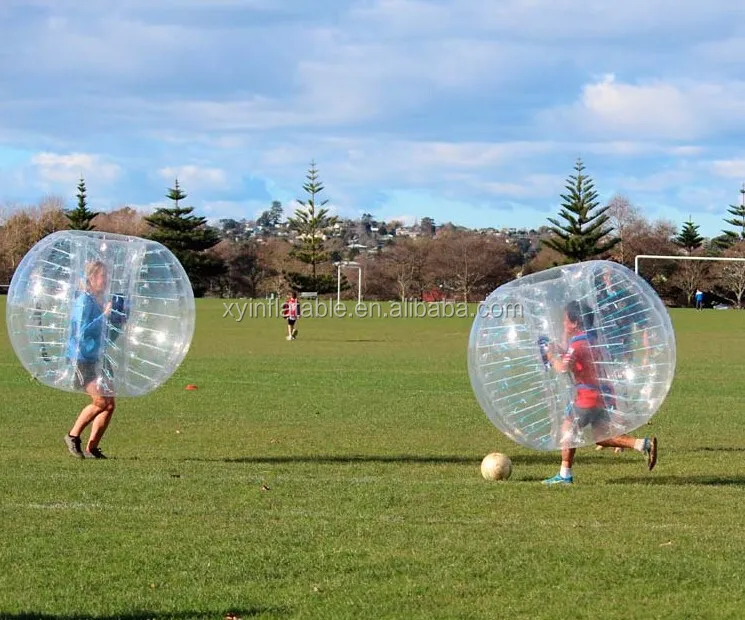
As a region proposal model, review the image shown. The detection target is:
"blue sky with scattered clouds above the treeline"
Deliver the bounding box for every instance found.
[0,0,745,235]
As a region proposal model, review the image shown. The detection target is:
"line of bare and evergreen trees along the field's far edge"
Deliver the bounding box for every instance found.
[0,159,745,307]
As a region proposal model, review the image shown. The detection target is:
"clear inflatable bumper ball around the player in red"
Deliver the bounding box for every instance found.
[468,261,676,450]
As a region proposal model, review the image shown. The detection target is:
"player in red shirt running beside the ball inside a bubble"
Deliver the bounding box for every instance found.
[543,301,657,485]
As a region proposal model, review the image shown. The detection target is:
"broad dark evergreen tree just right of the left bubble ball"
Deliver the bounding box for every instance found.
[145,179,226,296]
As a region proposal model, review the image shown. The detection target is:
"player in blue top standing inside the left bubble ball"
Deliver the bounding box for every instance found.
[64,261,116,459]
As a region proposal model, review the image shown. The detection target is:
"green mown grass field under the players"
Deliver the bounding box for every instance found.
[0,299,745,620]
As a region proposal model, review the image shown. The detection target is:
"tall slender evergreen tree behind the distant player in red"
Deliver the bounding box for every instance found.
[287,162,339,293]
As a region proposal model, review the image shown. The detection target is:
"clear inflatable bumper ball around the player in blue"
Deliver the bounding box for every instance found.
[6,231,195,396]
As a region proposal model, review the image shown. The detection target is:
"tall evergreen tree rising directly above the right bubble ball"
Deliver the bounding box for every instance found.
[543,159,620,261]
